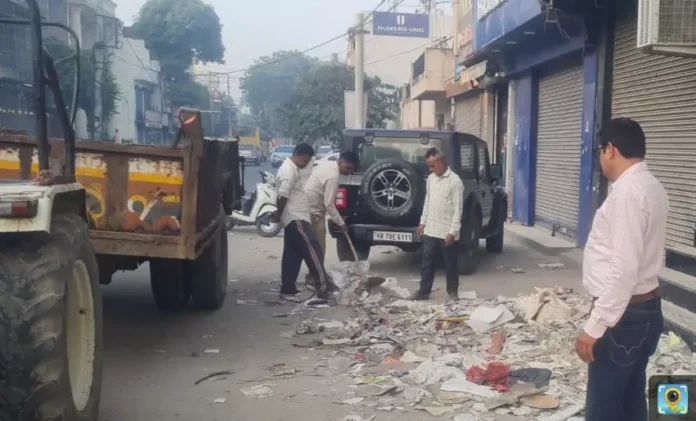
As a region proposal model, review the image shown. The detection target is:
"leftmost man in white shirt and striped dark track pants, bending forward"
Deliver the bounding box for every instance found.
[276,143,333,299]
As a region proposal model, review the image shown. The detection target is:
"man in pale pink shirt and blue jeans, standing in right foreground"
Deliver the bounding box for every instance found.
[576,118,669,421]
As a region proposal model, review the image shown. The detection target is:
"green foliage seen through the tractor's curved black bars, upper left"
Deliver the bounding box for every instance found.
[44,38,121,133]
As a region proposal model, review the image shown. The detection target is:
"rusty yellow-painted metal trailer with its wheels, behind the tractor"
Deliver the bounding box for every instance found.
[0,110,243,311]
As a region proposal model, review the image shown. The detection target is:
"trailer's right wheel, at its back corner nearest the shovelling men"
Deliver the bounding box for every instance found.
[187,211,228,310]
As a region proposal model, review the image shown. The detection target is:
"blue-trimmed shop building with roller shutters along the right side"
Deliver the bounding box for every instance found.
[448,0,696,253]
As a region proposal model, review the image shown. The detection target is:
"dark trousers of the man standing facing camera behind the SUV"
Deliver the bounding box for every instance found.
[420,235,459,296]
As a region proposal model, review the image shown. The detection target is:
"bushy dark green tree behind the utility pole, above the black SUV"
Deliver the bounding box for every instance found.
[280,64,399,143]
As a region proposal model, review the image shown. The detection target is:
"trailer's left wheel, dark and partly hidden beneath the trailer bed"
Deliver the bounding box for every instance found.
[150,259,191,312]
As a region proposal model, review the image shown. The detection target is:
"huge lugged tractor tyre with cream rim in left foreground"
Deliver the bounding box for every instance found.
[0,215,103,421]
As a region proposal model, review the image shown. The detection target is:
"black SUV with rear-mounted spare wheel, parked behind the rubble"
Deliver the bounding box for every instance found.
[329,129,508,274]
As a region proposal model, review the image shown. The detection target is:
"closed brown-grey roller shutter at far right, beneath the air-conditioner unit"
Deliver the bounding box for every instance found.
[612,16,696,248]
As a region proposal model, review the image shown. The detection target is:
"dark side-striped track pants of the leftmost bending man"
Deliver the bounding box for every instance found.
[280,220,330,294]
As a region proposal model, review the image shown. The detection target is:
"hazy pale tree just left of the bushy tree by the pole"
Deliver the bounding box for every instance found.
[241,51,316,135]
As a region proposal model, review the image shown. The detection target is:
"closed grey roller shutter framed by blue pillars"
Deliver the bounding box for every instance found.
[535,63,583,237]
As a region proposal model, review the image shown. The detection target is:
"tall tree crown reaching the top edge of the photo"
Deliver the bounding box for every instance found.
[133,0,225,78]
